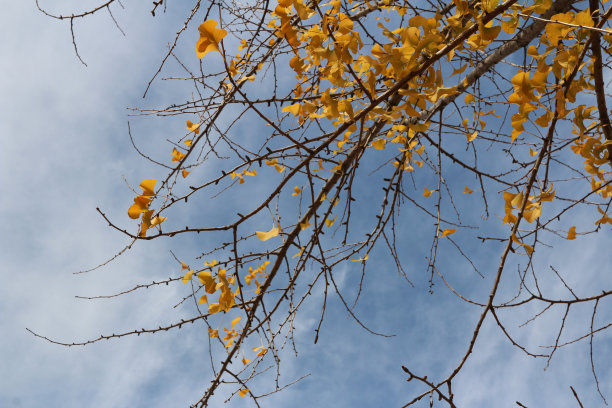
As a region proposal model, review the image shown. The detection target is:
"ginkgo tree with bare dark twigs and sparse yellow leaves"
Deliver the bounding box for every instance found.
[36,0,612,407]
